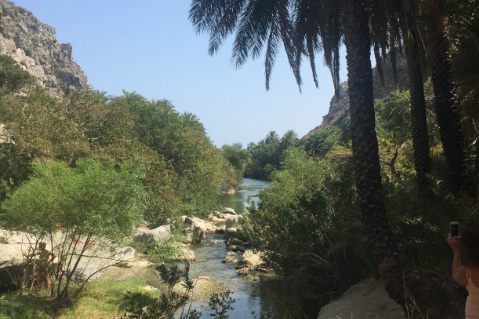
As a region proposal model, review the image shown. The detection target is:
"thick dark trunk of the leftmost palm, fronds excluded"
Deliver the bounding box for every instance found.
[344,0,397,261]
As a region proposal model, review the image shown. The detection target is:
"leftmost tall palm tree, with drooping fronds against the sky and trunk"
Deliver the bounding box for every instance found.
[190,0,458,313]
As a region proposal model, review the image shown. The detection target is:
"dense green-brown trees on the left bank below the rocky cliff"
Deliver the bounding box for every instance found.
[0,56,242,230]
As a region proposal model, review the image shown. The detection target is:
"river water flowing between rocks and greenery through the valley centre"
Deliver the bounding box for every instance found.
[186,178,298,319]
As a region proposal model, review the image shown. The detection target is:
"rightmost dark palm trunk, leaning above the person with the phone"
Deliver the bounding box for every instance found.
[428,1,476,199]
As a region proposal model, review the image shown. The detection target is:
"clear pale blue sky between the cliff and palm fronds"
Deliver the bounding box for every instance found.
[12,0,346,147]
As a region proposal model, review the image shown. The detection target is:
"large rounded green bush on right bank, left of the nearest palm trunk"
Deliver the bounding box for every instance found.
[245,150,374,302]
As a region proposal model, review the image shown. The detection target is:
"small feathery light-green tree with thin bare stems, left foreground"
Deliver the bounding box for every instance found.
[2,159,147,299]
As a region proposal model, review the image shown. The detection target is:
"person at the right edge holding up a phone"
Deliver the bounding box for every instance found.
[447,223,479,319]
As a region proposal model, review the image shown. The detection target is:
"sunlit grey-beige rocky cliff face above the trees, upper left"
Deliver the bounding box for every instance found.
[0,0,87,95]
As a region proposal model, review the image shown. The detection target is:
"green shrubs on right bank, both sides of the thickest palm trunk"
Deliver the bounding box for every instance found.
[244,91,475,311]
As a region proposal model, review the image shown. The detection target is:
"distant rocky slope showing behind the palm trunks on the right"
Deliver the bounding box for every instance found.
[302,55,408,139]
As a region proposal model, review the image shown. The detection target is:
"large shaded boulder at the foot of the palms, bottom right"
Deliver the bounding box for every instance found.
[318,278,405,319]
